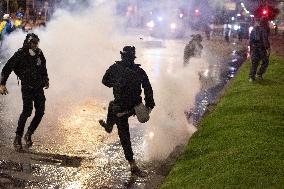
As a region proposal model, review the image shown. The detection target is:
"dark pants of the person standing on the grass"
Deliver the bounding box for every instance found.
[249,49,269,79]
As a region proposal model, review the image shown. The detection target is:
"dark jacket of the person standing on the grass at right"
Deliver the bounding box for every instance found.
[249,26,270,50]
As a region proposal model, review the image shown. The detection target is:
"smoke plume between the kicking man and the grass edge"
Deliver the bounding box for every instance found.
[144,59,207,160]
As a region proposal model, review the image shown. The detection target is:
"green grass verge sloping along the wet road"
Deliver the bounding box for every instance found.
[160,55,284,189]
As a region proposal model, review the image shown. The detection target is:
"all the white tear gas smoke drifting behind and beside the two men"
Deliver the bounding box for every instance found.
[1,1,209,159]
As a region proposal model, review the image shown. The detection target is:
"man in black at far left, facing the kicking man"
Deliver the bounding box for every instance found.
[0,33,49,151]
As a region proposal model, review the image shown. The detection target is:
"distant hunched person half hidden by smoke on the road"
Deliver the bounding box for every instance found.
[183,34,203,66]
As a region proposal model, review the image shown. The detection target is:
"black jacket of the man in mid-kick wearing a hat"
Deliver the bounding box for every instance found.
[102,61,155,110]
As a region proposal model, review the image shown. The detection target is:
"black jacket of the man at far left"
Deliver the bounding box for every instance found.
[1,49,49,88]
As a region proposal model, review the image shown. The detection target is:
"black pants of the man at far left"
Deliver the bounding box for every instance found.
[16,86,45,137]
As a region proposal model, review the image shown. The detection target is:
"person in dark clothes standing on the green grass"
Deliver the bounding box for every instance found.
[249,19,271,82]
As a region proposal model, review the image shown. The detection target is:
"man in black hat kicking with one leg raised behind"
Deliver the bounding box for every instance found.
[99,46,155,176]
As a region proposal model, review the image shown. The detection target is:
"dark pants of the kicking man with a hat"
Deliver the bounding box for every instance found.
[107,101,134,162]
